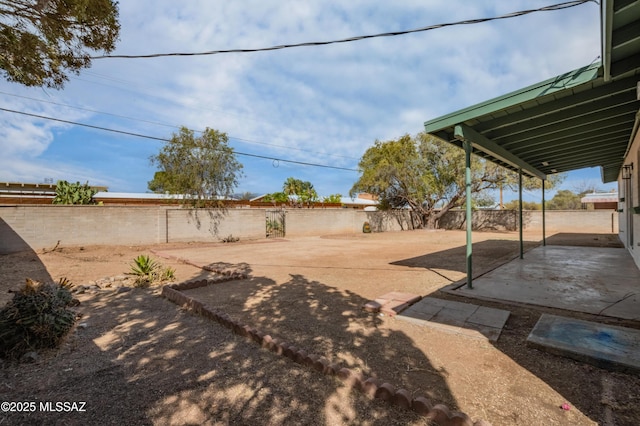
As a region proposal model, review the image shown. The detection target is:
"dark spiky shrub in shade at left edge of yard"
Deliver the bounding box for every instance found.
[0,279,79,358]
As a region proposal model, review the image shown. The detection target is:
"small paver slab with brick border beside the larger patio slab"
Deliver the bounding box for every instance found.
[397,297,510,342]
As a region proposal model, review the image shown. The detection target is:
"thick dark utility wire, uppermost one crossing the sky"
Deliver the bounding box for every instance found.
[91,0,598,59]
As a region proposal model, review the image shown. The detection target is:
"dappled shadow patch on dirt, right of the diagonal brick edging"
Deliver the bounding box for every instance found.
[185,266,457,415]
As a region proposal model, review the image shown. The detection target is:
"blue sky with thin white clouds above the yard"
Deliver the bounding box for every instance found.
[0,0,615,200]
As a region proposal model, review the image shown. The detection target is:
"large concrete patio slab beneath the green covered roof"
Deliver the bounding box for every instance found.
[453,246,640,320]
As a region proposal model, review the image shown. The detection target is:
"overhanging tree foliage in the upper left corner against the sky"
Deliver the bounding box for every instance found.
[0,0,120,89]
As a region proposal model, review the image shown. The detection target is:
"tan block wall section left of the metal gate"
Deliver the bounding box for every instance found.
[0,205,265,253]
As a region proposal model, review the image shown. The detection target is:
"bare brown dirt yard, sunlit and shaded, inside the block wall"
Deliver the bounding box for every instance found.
[0,231,640,426]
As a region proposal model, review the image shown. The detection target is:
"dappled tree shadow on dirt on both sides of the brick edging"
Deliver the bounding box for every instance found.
[0,264,440,425]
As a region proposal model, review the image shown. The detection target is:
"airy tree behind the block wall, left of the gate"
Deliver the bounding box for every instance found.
[149,127,242,207]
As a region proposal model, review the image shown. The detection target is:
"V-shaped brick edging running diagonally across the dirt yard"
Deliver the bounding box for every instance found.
[162,271,491,426]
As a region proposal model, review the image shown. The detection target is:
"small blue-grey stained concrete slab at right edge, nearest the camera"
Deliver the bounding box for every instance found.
[527,314,640,372]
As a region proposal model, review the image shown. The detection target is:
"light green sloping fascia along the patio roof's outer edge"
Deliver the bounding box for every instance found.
[424,62,602,133]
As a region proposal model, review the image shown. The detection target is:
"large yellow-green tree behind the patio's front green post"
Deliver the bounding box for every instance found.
[350,133,560,228]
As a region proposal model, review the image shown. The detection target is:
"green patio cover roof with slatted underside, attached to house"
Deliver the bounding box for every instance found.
[425,0,640,182]
